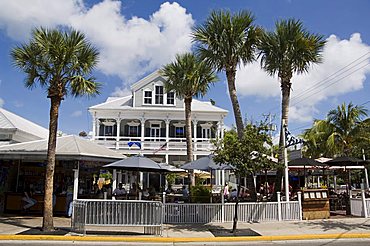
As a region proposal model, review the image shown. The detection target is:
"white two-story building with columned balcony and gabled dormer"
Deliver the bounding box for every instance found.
[89,71,228,165]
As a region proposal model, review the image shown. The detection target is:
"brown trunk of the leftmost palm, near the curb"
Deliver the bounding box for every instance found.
[42,96,61,231]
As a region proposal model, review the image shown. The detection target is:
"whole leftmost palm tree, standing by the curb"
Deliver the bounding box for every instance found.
[11,28,100,231]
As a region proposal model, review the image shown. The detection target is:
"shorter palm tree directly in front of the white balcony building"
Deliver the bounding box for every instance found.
[160,53,217,182]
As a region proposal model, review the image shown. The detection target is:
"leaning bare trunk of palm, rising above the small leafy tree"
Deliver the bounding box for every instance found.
[226,69,244,139]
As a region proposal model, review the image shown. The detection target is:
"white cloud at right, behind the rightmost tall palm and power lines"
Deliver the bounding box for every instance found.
[236,33,370,122]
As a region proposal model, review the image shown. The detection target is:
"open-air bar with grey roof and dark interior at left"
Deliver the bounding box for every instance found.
[0,136,124,214]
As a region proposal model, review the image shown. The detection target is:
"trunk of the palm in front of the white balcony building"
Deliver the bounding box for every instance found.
[184,97,195,185]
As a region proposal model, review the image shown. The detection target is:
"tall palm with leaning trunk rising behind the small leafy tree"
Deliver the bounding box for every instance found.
[192,10,260,139]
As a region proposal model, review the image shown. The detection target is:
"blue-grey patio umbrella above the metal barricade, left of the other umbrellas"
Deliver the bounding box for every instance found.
[103,156,168,172]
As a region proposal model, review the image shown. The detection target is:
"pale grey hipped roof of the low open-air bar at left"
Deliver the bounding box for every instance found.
[0,135,125,161]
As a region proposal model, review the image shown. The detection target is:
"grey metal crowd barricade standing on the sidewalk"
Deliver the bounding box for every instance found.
[72,200,163,234]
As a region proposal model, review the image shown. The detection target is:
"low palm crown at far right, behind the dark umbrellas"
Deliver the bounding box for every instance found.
[304,103,370,156]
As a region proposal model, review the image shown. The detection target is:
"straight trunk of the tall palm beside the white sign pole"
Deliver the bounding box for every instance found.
[274,79,292,200]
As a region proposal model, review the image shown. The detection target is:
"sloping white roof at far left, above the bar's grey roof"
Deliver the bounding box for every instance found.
[0,108,49,139]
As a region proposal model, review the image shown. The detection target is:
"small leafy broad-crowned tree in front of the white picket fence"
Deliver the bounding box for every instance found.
[214,124,271,233]
